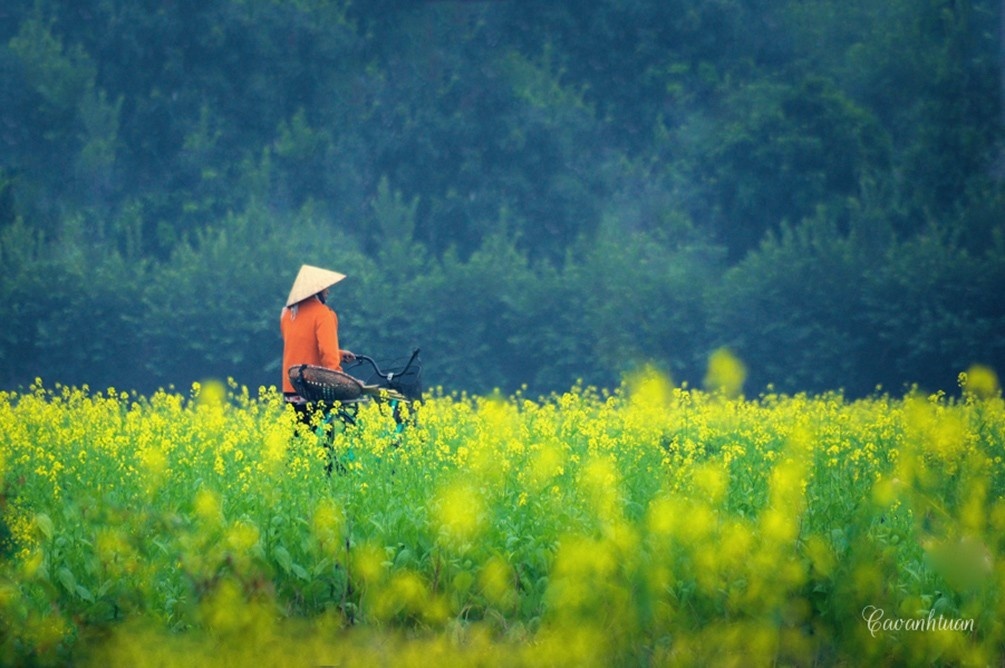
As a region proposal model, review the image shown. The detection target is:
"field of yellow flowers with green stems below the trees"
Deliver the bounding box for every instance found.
[0,361,1005,666]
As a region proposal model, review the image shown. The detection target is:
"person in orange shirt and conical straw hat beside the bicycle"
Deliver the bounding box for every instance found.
[279,264,356,409]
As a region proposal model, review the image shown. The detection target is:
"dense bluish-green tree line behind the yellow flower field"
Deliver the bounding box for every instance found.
[0,0,1005,394]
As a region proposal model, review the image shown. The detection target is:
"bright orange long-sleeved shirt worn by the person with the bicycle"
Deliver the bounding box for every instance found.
[279,297,342,392]
